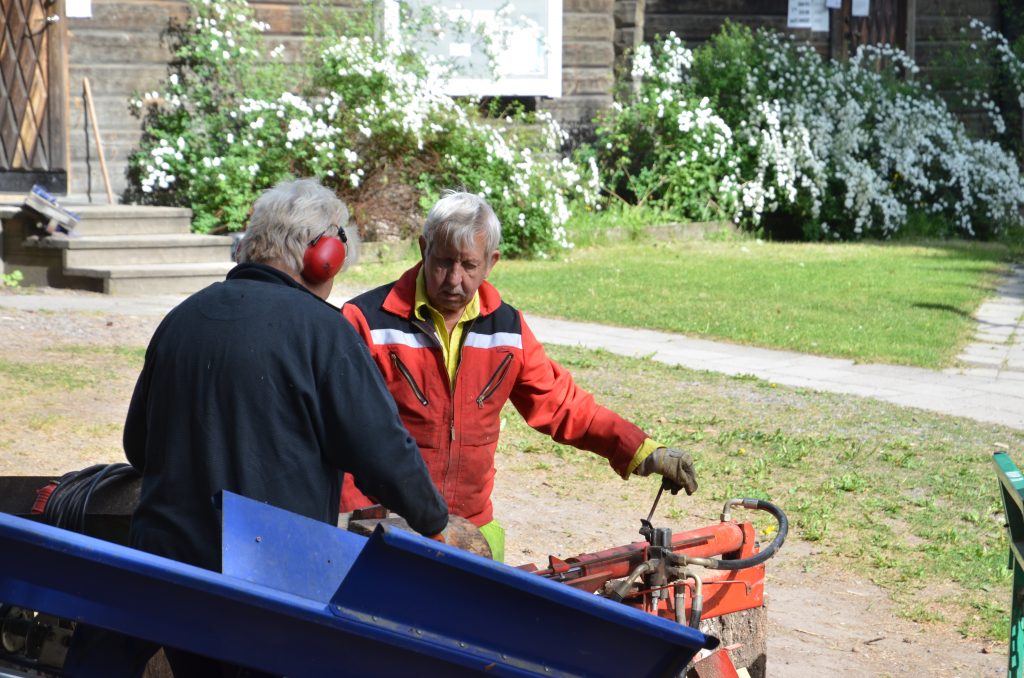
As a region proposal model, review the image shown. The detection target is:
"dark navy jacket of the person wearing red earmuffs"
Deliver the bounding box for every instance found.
[124,264,447,569]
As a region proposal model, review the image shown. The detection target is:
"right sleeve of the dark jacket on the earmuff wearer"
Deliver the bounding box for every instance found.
[319,327,449,536]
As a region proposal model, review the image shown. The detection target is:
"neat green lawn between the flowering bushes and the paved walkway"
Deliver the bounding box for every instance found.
[343,240,1008,368]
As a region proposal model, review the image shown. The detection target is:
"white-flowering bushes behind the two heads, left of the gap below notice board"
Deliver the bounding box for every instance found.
[125,0,597,256]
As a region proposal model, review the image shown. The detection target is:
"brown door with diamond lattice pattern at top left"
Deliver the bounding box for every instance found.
[0,0,68,194]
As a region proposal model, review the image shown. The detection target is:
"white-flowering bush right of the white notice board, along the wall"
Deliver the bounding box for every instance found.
[597,25,1024,240]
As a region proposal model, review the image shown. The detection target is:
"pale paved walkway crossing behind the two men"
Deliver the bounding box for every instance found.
[0,267,1024,430]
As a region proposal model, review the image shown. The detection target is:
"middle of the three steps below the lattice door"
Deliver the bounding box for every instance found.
[25,234,231,269]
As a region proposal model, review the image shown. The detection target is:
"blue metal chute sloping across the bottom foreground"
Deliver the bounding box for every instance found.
[0,493,716,676]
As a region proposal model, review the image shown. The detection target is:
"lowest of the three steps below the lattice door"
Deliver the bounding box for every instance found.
[63,261,234,295]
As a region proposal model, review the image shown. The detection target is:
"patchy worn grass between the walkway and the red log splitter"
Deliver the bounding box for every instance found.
[497,346,1024,642]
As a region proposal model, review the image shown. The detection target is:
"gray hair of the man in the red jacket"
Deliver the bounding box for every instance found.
[423,190,502,254]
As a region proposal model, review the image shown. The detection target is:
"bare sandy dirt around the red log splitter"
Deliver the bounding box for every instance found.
[495,458,1010,678]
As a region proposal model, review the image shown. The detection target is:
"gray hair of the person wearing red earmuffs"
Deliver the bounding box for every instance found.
[238,179,348,274]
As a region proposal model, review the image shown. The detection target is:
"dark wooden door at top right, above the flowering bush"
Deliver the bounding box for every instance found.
[830,0,915,59]
